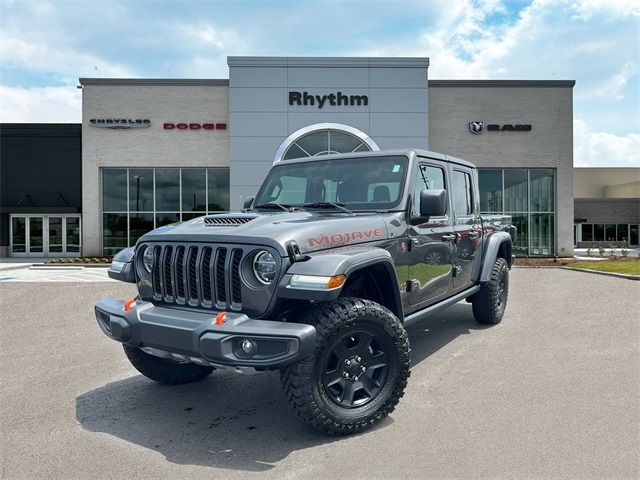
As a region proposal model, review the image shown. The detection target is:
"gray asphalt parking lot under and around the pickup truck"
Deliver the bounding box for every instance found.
[0,268,640,479]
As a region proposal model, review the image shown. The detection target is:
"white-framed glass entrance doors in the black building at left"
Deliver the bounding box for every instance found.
[10,215,81,257]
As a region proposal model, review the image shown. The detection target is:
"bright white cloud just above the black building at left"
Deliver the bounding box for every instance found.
[0,85,82,123]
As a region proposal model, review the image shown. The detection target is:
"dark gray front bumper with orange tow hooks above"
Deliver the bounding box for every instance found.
[95,298,316,369]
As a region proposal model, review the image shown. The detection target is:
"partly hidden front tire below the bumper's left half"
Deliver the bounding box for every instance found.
[122,345,214,385]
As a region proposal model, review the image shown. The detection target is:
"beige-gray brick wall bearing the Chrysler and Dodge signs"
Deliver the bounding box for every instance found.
[80,79,229,256]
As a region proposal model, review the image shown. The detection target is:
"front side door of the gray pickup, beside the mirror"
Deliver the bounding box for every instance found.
[408,161,455,308]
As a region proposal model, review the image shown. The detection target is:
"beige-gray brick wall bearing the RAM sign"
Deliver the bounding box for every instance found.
[429,80,573,256]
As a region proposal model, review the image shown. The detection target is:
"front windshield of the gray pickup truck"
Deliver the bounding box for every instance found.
[254,156,409,210]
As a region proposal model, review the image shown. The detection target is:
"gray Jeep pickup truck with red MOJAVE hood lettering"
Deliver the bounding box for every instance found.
[95,150,515,435]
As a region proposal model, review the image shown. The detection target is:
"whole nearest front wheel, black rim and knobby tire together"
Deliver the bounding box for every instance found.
[281,298,411,435]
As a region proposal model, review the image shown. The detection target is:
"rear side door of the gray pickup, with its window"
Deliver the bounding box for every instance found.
[450,164,482,290]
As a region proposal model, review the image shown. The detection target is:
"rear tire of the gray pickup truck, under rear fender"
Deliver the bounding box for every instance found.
[471,258,509,325]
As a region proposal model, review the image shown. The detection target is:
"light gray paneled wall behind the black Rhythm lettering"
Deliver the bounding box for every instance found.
[228,57,429,209]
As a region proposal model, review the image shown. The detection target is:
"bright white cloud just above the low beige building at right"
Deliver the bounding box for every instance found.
[573,118,640,167]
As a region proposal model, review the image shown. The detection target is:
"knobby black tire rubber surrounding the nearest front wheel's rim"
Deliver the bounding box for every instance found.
[280,297,411,435]
